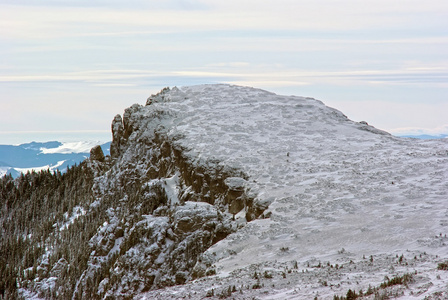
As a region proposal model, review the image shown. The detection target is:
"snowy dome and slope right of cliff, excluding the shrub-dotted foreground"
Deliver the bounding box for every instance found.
[121,85,448,298]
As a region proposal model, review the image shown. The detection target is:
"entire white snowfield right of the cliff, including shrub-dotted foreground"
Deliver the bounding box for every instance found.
[127,85,448,299]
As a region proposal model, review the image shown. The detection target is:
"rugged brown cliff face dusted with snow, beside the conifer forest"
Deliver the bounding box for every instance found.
[16,85,267,299]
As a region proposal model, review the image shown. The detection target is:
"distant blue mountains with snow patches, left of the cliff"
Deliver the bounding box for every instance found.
[0,141,110,177]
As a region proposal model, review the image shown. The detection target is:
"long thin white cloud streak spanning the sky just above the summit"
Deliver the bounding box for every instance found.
[0,66,448,87]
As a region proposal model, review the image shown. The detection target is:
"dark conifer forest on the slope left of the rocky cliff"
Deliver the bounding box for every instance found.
[0,163,97,299]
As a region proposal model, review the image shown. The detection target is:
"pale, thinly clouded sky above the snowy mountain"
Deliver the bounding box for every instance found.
[0,0,448,144]
